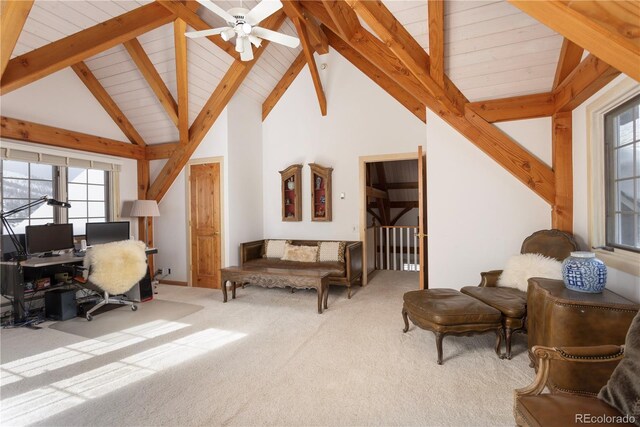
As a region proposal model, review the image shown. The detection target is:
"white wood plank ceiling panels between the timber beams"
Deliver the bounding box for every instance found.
[14,0,562,144]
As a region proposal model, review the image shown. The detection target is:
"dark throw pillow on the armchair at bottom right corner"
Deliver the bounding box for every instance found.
[598,314,640,422]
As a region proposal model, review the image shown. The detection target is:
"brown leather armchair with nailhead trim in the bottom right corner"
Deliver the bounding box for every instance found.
[513,345,624,427]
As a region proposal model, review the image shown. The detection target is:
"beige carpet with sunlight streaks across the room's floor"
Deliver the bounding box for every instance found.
[0,272,533,426]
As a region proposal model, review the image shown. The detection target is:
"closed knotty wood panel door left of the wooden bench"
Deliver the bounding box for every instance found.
[189,163,221,289]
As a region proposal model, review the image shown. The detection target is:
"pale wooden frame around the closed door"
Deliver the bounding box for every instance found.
[185,157,227,287]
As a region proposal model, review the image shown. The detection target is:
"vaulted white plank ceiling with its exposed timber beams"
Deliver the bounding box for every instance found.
[0,0,640,228]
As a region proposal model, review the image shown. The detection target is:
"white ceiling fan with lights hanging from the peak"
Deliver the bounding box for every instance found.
[185,0,300,61]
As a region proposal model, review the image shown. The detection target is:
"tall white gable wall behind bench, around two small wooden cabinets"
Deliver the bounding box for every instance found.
[262,50,426,240]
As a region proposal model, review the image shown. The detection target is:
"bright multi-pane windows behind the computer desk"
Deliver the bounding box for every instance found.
[0,160,110,235]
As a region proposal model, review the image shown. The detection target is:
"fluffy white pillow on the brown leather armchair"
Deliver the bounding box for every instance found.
[498,254,562,292]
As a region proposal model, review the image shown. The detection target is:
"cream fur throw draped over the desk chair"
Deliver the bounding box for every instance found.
[84,240,147,295]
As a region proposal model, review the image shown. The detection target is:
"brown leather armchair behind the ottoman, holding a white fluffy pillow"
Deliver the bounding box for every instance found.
[461,229,578,359]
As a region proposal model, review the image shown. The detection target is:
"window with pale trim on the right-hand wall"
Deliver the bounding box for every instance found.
[585,78,640,276]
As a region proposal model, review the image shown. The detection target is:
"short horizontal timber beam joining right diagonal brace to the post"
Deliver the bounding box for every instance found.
[466,93,556,123]
